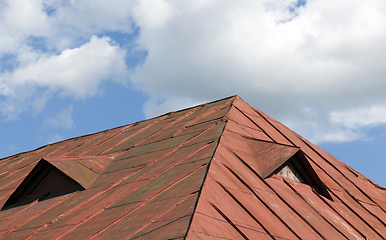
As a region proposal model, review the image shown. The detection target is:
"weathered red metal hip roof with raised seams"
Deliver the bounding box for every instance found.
[0,96,386,239]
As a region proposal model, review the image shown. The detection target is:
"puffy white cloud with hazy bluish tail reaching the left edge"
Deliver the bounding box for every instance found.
[0,36,127,119]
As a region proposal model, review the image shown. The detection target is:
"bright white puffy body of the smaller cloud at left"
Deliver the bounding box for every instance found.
[11,36,126,97]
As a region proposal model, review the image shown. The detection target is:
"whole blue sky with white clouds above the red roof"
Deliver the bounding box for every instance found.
[0,0,386,187]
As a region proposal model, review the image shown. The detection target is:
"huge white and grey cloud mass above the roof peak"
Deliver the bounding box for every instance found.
[128,0,386,142]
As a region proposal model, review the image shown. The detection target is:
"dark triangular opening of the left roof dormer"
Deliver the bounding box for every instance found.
[1,159,84,210]
